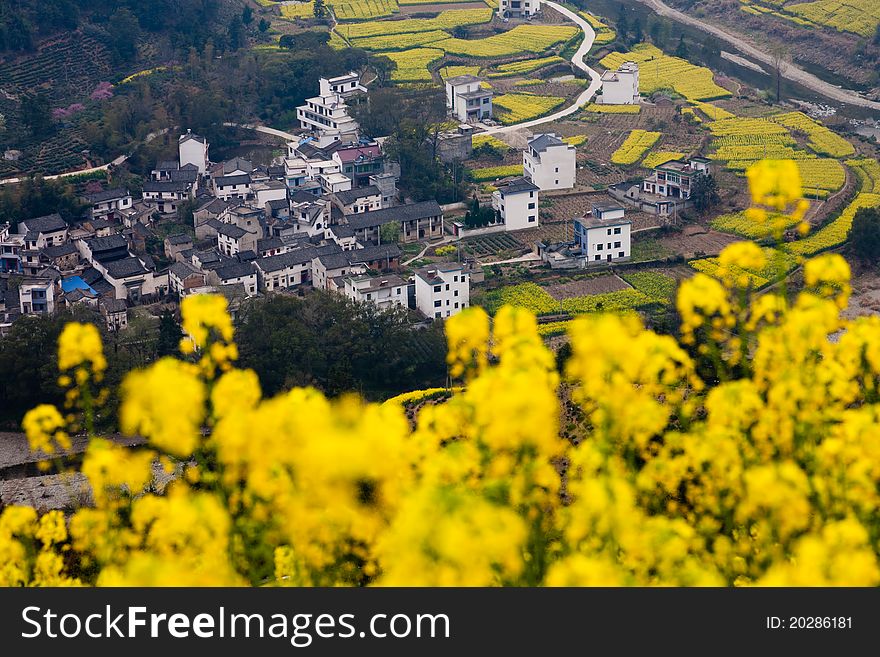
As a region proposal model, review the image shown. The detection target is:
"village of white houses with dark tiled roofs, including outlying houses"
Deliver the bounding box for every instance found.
[0,57,708,331]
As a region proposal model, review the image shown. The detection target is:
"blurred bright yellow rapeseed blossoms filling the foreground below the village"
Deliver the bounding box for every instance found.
[0,164,880,586]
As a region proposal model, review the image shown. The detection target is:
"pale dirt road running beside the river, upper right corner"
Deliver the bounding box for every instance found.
[636,0,880,110]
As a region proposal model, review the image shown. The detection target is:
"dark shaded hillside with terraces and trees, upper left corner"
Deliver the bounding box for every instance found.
[0,0,244,177]
